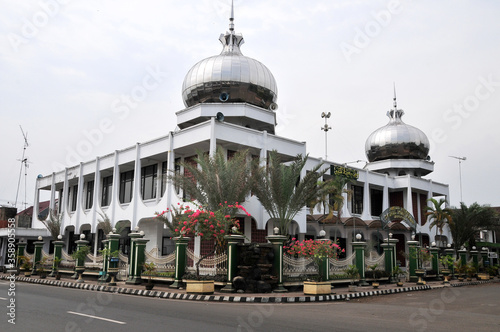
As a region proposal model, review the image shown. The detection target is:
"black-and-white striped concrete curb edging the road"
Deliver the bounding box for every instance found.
[0,276,450,303]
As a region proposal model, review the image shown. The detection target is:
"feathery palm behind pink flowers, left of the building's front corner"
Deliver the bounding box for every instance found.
[169,148,252,215]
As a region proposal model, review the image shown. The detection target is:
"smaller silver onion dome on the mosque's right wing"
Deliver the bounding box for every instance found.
[365,105,430,162]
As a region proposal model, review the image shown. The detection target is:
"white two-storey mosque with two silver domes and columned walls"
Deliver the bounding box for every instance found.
[1,3,452,268]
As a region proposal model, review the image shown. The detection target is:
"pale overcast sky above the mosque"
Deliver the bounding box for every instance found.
[0,0,500,207]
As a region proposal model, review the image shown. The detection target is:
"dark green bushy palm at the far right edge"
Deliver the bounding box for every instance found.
[450,202,500,250]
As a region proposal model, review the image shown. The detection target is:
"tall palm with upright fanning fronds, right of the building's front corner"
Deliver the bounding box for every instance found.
[253,150,327,235]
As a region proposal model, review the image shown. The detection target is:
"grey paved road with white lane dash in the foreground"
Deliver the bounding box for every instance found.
[0,282,500,332]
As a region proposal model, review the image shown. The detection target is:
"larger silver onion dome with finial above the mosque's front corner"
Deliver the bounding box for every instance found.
[182,9,278,110]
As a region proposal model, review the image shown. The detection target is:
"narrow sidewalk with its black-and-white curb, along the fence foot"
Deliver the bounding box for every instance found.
[0,273,499,303]
